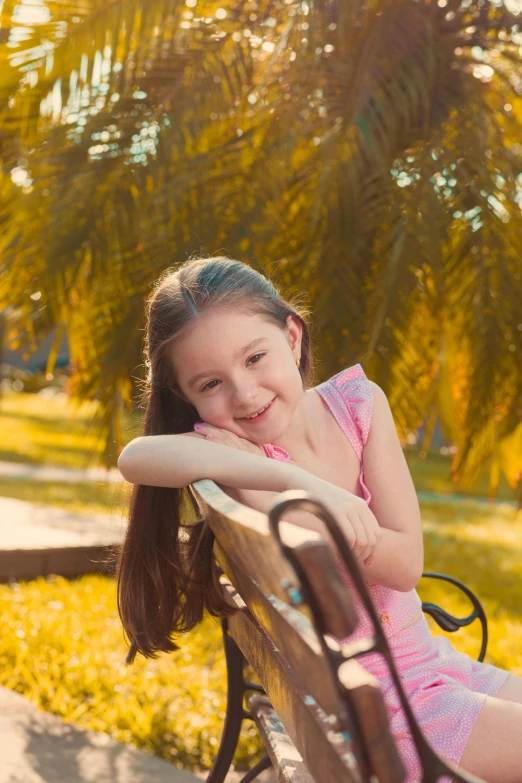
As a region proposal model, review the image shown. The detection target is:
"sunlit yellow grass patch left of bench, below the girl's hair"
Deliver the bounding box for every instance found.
[0,576,260,770]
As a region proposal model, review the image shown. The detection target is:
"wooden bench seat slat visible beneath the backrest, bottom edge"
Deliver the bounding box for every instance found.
[248,694,315,783]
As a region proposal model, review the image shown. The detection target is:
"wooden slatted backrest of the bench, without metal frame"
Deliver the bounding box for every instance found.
[193,481,405,783]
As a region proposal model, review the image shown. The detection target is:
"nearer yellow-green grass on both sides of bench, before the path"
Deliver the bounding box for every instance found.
[0,503,522,770]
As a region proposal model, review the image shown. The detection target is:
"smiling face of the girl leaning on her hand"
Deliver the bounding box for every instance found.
[170,310,303,443]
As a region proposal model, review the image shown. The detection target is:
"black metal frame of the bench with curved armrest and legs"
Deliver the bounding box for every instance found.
[207,497,488,783]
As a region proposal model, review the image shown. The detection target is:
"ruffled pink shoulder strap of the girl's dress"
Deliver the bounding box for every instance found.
[315,364,373,452]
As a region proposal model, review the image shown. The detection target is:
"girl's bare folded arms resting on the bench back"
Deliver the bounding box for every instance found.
[118,402,423,591]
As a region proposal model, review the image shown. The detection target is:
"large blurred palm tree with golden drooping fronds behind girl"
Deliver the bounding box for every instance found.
[0,0,522,496]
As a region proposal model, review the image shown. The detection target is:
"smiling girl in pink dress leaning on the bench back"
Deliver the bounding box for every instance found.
[118,258,522,783]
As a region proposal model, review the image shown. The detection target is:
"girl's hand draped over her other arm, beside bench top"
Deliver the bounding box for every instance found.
[292,471,382,566]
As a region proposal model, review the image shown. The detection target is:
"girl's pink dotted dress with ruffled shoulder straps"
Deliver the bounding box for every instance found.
[264,364,509,783]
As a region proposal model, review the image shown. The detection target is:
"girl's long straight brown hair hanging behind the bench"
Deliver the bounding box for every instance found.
[117,257,313,664]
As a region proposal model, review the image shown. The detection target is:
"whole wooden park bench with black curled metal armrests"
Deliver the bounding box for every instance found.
[192,480,487,783]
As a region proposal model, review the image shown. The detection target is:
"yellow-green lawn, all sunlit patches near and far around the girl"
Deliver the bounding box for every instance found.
[0,393,522,770]
